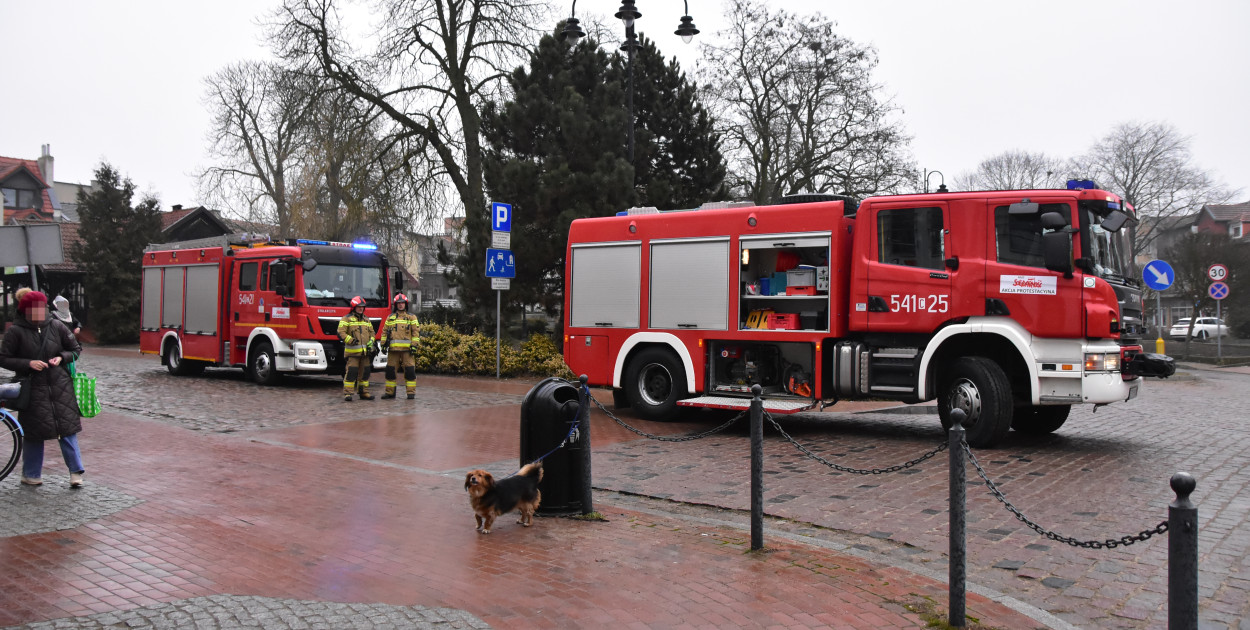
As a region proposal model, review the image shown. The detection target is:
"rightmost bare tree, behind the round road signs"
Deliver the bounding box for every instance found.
[1070,123,1233,256]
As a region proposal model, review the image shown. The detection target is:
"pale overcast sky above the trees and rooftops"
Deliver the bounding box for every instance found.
[0,0,1250,213]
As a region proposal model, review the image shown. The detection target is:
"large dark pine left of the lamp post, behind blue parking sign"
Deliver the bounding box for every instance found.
[477,28,634,325]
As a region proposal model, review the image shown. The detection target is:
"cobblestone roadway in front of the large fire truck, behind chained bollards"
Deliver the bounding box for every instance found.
[595,370,1250,630]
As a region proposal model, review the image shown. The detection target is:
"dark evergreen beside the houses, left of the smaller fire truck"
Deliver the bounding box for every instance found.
[74,163,160,344]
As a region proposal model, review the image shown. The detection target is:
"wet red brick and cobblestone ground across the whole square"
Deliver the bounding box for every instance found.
[0,348,1250,630]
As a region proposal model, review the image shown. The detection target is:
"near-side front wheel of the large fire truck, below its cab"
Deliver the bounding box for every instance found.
[938,356,1013,449]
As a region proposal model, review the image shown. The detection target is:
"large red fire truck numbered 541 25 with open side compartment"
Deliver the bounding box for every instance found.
[565,188,1174,446]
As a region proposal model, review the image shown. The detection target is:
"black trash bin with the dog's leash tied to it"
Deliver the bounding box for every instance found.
[521,378,590,515]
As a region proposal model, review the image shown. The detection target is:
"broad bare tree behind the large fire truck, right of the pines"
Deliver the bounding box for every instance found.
[699,0,916,204]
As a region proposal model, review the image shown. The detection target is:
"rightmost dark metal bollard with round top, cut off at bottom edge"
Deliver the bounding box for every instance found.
[1168,473,1198,630]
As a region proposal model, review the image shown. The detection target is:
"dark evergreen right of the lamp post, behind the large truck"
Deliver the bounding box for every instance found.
[609,38,729,210]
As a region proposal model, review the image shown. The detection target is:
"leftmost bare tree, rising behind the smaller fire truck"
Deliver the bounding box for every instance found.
[200,61,315,238]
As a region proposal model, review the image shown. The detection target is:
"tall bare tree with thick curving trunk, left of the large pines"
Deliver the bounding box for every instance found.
[271,0,545,312]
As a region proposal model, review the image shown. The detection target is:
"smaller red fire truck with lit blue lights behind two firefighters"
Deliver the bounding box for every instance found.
[139,235,403,385]
